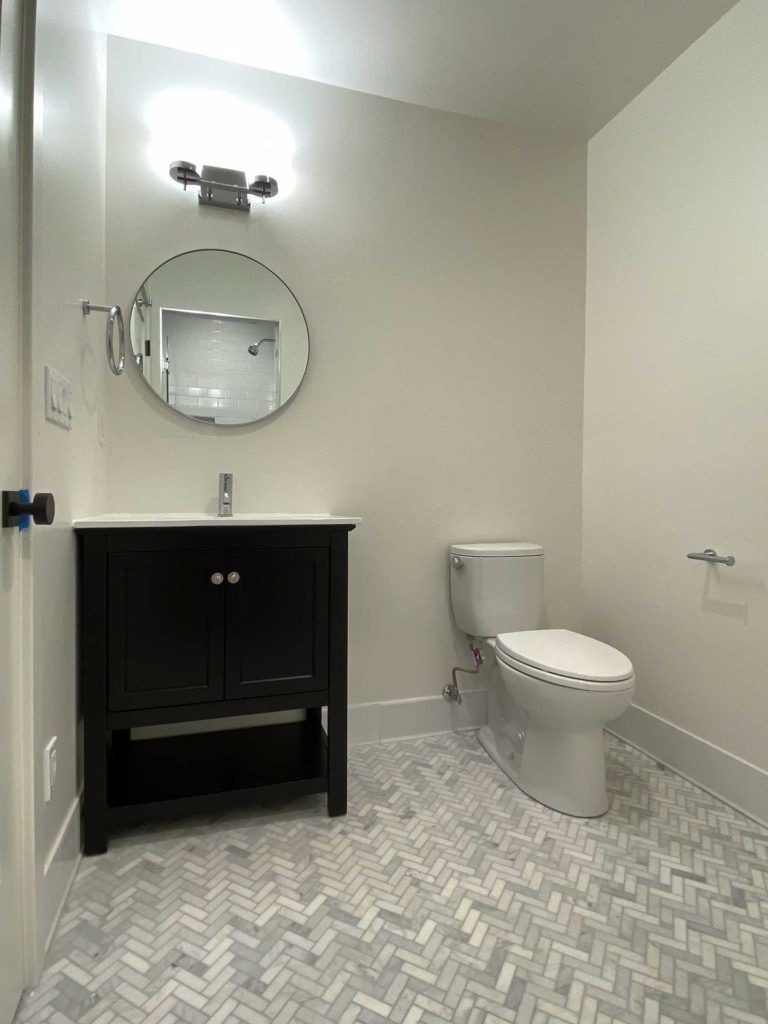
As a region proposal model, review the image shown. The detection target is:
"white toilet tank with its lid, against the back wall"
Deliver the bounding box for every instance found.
[450,541,544,637]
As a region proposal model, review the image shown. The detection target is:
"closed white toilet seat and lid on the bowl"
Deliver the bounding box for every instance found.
[496,630,635,692]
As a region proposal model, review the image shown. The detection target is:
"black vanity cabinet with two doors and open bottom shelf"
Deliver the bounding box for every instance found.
[75,524,354,854]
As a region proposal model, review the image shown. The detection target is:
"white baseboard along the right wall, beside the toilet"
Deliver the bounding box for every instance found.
[607,705,768,825]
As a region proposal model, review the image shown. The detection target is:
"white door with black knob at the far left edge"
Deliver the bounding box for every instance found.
[0,0,24,1022]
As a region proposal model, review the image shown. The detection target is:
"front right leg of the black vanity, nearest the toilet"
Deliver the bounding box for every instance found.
[328,531,347,817]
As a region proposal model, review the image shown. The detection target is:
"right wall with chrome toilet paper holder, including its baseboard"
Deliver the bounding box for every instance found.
[584,0,768,817]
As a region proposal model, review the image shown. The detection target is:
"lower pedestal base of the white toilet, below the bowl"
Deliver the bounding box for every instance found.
[477,725,609,818]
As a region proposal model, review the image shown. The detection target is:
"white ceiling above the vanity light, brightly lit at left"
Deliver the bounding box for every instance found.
[104,0,735,138]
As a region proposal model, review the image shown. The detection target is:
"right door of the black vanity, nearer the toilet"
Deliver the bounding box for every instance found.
[225,548,329,698]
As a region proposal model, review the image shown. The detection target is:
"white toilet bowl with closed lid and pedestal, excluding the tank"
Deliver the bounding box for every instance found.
[479,630,635,817]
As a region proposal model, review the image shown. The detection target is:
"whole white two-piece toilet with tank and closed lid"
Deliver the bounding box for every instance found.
[451,543,635,817]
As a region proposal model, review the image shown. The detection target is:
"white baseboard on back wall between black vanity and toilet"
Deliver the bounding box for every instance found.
[348,690,485,743]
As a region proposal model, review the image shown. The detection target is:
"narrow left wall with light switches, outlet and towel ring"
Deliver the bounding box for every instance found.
[23,0,106,966]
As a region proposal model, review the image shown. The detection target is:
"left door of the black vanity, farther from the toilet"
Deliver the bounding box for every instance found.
[109,551,227,711]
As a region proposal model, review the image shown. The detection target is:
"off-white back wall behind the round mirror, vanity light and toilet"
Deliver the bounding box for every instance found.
[106,39,586,712]
